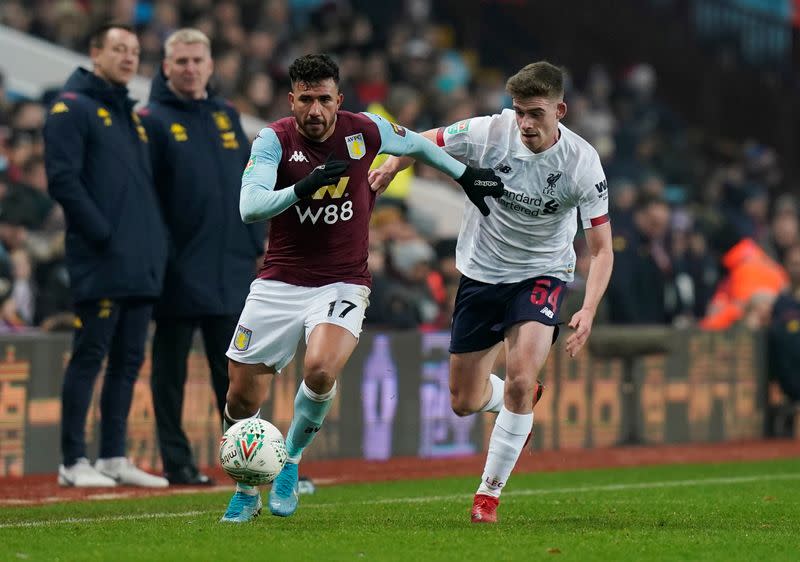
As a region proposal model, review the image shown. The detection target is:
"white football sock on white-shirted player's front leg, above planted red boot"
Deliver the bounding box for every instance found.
[478,406,533,498]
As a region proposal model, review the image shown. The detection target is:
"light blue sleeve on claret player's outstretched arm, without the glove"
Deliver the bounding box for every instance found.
[364,113,467,179]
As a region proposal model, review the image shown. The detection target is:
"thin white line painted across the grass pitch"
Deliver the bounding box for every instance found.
[0,473,800,529]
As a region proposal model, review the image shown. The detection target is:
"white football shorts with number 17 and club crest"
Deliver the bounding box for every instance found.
[226,279,370,371]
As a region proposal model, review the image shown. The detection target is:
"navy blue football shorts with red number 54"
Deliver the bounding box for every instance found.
[450,275,567,353]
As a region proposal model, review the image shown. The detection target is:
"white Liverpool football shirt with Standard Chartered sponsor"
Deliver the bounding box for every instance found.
[437,109,608,283]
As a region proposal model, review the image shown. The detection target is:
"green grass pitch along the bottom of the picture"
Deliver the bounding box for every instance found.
[0,459,800,562]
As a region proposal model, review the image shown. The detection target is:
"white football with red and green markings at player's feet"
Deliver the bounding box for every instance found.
[219,418,288,486]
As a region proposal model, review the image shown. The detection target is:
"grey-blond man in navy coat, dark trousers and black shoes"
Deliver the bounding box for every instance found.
[141,29,264,484]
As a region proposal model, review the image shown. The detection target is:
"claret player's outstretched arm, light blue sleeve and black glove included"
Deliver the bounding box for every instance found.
[365,113,503,216]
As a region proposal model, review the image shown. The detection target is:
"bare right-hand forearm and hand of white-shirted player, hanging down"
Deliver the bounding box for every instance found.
[566,222,614,357]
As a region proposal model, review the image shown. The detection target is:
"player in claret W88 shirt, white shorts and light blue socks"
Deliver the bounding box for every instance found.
[222,55,503,522]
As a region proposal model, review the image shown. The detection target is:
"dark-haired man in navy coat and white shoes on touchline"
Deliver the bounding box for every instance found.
[44,25,167,487]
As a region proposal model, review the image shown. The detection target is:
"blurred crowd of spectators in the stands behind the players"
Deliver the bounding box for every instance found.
[0,0,800,344]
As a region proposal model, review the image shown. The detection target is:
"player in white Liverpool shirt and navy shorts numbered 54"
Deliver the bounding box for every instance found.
[370,62,614,523]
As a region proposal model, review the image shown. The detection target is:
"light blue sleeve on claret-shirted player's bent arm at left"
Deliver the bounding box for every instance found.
[239,127,299,223]
